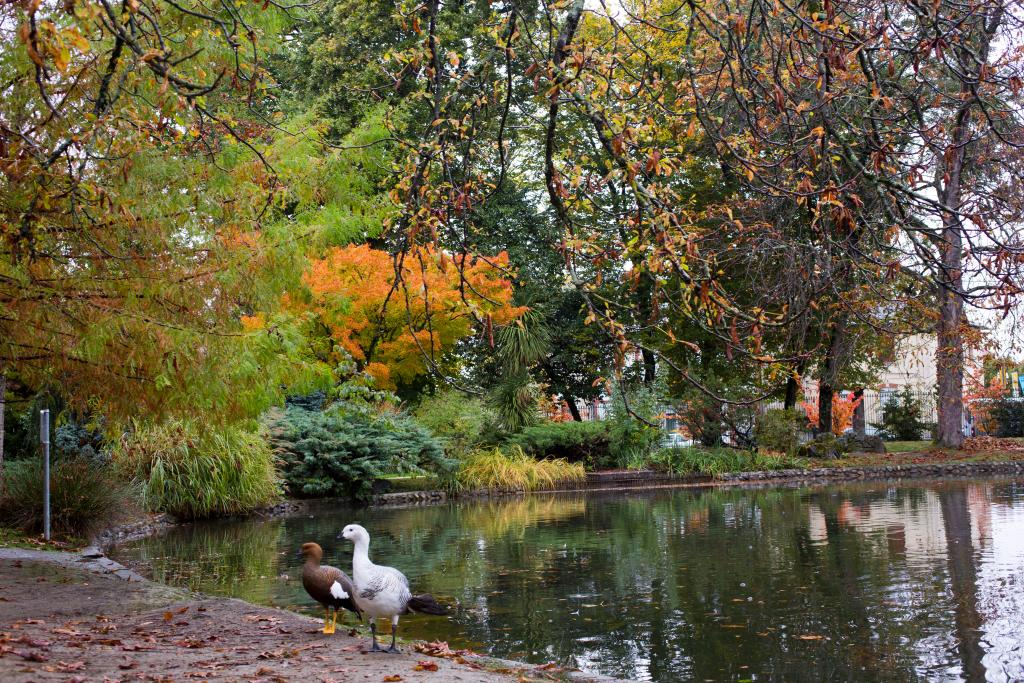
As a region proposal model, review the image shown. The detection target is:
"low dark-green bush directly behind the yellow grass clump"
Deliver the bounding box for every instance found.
[506,422,612,469]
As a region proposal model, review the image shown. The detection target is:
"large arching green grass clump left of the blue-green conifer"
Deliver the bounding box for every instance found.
[114,421,281,519]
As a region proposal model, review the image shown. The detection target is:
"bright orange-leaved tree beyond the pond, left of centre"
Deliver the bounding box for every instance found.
[300,245,522,389]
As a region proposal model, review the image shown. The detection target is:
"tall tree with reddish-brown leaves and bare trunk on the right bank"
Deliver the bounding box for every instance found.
[689,0,1024,446]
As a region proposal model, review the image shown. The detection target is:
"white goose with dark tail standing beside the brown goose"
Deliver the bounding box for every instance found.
[339,524,447,652]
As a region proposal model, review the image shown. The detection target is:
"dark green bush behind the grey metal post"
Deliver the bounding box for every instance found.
[0,457,130,537]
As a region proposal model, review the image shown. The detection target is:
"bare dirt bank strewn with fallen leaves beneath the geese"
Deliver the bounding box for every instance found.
[0,549,587,683]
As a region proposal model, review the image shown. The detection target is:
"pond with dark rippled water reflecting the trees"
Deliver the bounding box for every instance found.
[113,478,1024,681]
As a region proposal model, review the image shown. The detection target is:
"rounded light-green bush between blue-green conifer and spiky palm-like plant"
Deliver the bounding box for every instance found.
[414,391,498,457]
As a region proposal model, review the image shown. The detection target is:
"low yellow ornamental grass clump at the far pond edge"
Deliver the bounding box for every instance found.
[456,445,587,490]
